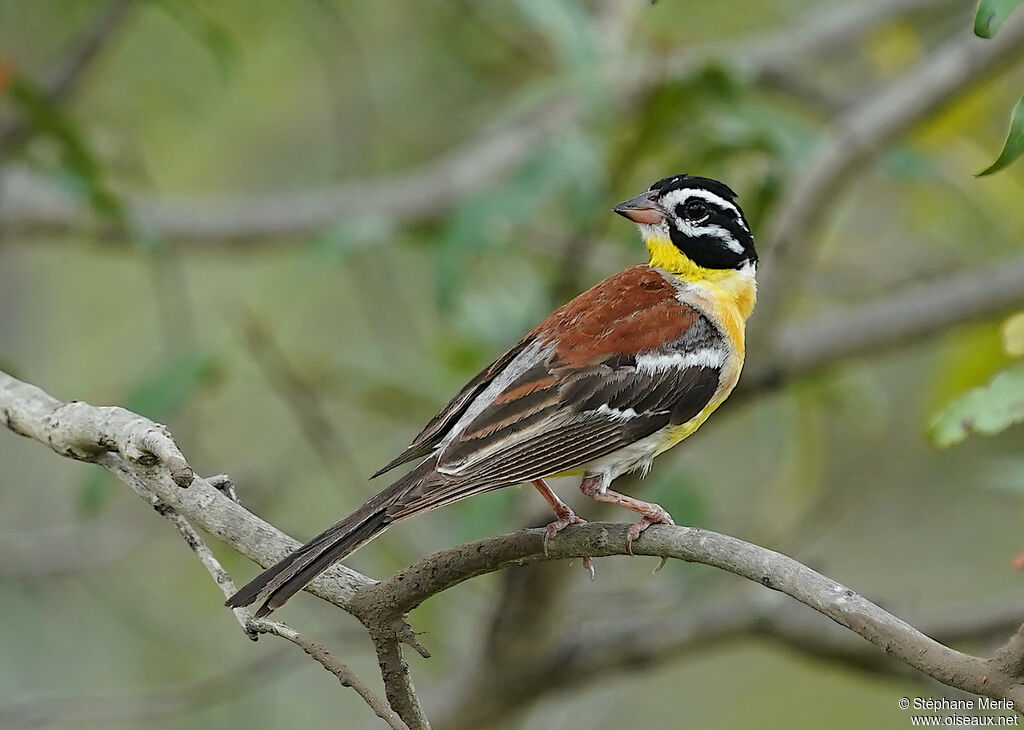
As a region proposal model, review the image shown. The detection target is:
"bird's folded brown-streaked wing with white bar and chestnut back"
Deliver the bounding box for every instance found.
[389,266,728,519]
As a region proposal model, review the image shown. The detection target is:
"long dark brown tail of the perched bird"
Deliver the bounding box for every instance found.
[225,459,436,617]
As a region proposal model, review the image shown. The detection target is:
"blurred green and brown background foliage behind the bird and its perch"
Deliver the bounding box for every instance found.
[0,0,1024,730]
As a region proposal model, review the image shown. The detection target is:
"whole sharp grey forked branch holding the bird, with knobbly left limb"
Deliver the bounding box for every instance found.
[0,354,1024,728]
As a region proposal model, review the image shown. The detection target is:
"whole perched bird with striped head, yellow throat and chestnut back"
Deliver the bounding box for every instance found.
[226,174,758,617]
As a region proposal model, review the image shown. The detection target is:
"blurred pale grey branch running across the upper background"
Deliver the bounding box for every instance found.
[0,0,954,245]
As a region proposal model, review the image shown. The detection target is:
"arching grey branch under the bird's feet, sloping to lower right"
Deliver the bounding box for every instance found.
[351,523,1024,711]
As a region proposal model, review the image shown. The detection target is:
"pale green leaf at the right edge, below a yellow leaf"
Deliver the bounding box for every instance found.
[931,363,1024,447]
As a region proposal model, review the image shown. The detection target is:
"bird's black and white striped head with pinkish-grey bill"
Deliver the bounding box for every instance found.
[613,175,758,269]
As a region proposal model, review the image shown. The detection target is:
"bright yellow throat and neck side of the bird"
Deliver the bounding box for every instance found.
[644,235,757,354]
